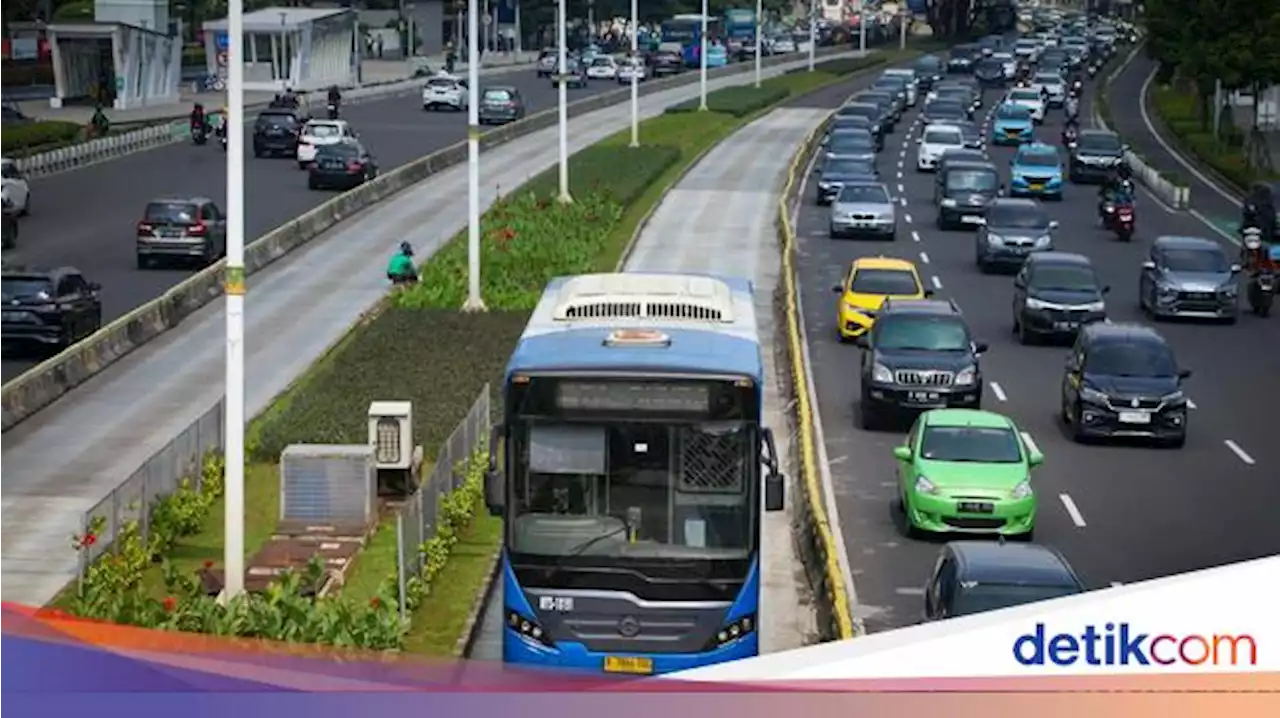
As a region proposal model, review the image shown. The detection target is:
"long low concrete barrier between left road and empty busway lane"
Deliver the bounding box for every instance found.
[0,47,880,431]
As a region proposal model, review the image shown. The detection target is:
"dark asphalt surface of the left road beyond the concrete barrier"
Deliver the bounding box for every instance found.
[0,67,660,381]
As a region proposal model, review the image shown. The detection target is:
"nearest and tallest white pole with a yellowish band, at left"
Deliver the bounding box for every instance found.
[223,0,244,600]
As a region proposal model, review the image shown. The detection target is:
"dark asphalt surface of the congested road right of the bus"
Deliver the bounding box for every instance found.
[797,63,1280,631]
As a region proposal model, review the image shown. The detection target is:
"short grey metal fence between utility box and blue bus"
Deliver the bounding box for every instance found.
[396,384,492,617]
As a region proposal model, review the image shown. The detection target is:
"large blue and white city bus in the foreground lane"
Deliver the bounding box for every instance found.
[485,273,783,676]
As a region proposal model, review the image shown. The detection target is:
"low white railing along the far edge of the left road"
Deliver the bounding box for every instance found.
[8,55,532,178]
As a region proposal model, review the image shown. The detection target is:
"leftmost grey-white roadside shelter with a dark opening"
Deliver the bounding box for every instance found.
[46,22,182,110]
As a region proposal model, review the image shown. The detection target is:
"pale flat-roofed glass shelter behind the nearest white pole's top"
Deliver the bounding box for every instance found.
[204,8,360,92]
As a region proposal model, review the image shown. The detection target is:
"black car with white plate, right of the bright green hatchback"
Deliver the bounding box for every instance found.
[1062,323,1192,448]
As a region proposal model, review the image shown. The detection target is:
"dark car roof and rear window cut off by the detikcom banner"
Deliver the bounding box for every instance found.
[924,541,1085,621]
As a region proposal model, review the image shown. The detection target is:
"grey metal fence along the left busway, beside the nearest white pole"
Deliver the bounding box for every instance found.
[79,399,224,580]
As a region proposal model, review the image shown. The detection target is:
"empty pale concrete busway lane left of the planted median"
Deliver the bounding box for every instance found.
[0,51,849,604]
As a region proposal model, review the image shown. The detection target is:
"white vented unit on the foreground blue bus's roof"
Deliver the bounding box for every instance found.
[554,274,733,323]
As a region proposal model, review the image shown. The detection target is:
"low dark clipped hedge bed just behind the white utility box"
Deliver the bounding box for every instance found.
[247,308,529,462]
